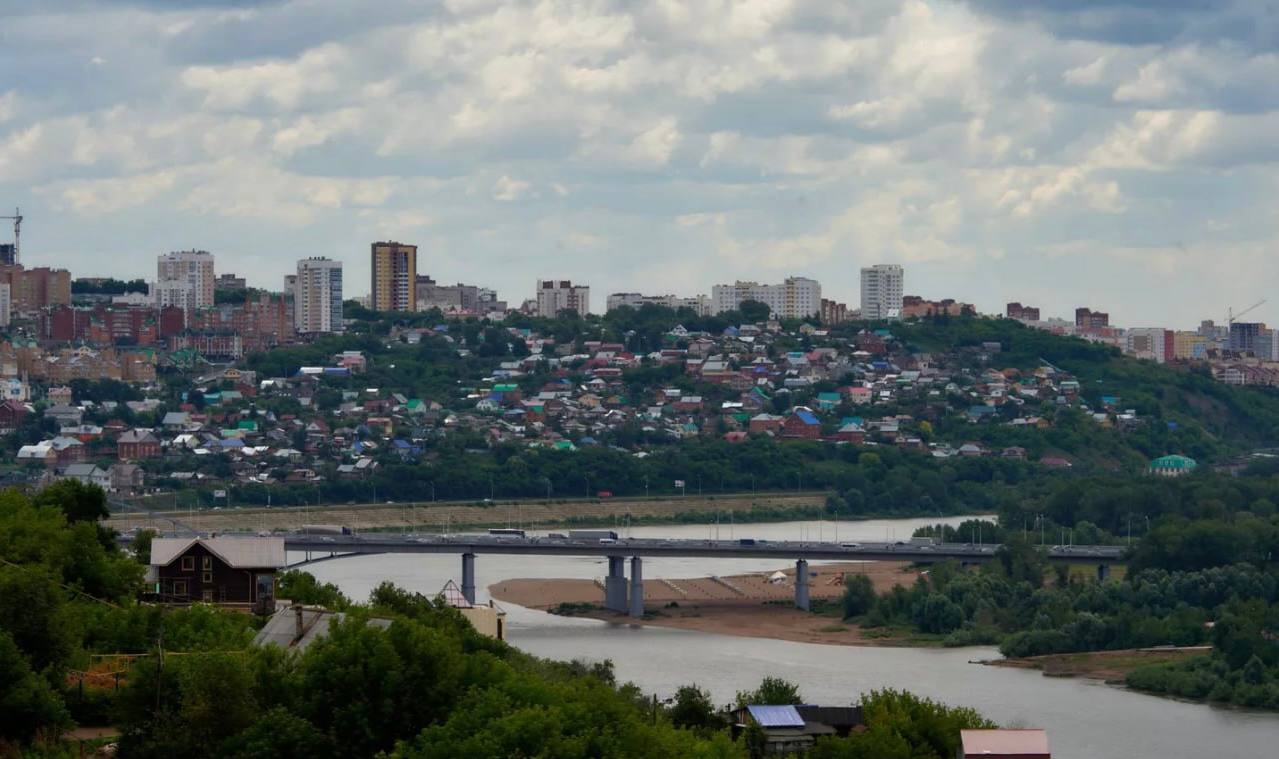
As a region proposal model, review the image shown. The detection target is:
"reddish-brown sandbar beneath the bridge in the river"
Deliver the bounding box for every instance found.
[489,562,918,645]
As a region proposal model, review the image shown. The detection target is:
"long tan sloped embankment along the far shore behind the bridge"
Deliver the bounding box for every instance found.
[106,491,826,531]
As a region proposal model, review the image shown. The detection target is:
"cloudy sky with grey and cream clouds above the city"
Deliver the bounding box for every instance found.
[0,0,1279,326]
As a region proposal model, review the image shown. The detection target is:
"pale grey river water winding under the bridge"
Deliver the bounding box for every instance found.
[307,517,1279,759]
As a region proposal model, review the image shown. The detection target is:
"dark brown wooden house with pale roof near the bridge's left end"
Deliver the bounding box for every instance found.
[147,538,288,613]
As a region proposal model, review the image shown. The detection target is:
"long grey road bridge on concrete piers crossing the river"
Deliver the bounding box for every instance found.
[284,534,1124,617]
